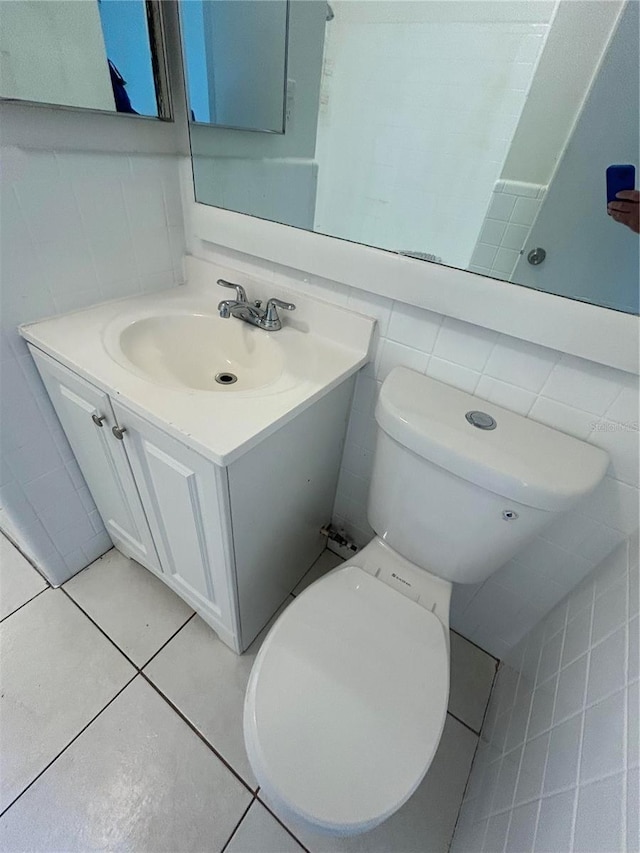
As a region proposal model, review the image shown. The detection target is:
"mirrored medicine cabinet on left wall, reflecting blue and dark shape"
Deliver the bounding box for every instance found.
[0,0,170,118]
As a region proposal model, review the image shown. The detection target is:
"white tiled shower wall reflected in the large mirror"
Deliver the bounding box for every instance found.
[315,0,556,268]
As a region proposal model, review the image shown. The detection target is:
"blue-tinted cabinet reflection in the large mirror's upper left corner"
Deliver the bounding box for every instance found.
[180,0,287,133]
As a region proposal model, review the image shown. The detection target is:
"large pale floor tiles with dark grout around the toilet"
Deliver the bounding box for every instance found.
[0,537,495,853]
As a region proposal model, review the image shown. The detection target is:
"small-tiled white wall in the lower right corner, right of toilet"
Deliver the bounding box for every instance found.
[451,536,640,853]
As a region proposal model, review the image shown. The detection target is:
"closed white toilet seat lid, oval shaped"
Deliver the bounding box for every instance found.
[244,565,449,835]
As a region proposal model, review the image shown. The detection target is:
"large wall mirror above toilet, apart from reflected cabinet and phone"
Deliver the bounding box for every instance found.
[191,0,639,313]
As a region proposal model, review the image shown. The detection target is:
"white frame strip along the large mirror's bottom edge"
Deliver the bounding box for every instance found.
[190,200,640,375]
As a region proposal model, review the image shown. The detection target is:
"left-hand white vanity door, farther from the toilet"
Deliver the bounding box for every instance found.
[29,346,161,572]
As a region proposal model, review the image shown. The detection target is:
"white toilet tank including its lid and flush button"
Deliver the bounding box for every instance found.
[368,367,609,583]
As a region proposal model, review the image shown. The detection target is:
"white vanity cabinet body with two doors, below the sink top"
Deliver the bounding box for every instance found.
[29,344,355,652]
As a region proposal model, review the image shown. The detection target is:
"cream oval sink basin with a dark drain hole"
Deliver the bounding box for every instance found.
[118,314,284,392]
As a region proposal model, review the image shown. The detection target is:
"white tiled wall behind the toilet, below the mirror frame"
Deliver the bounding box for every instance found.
[185,228,639,658]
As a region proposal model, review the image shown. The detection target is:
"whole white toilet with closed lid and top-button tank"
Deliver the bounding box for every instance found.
[244,367,608,835]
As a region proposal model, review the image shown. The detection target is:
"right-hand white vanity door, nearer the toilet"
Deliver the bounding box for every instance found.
[112,400,239,651]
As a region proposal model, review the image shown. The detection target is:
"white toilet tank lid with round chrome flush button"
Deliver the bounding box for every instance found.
[376,367,609,512]
